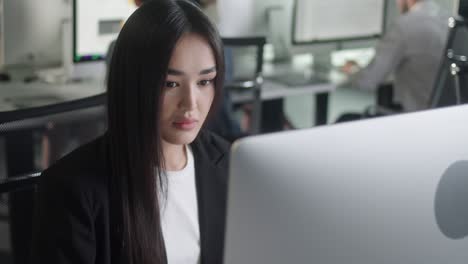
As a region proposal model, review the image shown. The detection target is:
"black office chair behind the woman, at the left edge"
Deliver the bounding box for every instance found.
[0,94,106,264]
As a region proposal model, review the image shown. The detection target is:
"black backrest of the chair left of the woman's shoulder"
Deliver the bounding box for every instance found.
[0,94,106,175]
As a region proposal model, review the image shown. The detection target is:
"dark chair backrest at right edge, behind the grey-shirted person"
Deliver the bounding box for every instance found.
[429,20,468,108]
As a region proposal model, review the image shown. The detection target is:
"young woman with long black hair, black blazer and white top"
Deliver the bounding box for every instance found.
[33,0,229,264]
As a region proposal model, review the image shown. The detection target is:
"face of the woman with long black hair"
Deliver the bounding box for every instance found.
[159,33,216,145]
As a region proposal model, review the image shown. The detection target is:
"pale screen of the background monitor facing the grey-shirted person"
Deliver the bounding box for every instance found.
[292,0,385,44]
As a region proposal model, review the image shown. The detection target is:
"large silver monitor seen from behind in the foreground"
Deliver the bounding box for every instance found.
[224,106,468,264]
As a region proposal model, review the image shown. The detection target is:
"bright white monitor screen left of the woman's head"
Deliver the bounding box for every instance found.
[73,0,136,62]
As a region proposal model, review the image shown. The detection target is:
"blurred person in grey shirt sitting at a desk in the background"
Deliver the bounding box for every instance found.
[342,0,448,112]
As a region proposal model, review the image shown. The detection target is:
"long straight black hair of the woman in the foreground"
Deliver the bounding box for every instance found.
[108,0,224,264]
